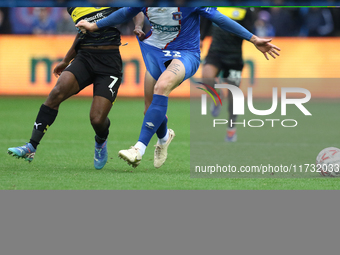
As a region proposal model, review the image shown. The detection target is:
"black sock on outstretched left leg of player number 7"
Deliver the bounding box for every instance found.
[30,104,58,149]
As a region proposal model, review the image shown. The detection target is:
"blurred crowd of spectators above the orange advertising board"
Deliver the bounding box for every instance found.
[0,5,340,37]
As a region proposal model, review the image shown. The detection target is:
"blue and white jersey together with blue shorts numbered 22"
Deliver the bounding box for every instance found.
[97,7,253,80]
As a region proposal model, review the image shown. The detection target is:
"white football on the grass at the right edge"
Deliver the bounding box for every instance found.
[316,147,340,177]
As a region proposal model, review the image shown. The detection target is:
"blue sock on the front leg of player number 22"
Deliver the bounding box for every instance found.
[138,94,168,146]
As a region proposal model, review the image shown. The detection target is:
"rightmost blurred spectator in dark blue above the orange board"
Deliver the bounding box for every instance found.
[301,8,334,36]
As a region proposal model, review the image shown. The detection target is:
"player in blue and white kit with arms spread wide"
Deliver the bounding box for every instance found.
[76,7,280,168]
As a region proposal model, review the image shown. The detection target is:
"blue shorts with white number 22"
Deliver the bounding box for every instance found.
[138,40,200,81]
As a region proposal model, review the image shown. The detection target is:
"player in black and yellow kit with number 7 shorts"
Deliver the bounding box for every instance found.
[8,7,144,169]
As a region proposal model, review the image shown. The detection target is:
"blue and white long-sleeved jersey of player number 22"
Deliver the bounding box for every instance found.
[97,7,253,52]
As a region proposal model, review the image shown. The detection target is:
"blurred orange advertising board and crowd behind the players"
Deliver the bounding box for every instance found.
[0,5,340,97]
